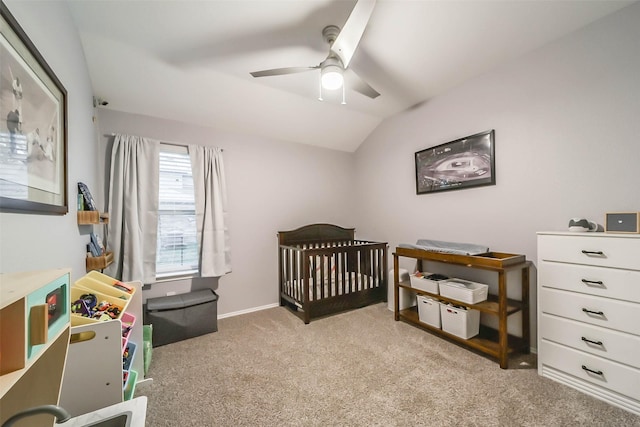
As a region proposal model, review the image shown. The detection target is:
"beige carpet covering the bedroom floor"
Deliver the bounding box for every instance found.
[136,304,640,427]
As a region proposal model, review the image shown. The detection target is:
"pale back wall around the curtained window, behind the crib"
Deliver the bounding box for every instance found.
[98,109,356,315]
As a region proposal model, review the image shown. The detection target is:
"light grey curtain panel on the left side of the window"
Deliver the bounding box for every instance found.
[106,135,160,283]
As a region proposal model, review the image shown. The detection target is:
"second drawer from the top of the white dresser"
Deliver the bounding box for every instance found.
[538,260,640,302]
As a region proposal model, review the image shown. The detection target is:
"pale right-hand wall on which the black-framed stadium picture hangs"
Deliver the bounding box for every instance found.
[355,3,640,342]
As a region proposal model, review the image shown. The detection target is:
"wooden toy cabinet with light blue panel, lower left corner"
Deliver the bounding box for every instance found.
[0,269,70,427]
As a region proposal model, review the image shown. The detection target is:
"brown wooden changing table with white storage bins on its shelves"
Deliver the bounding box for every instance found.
[393,245,531,369]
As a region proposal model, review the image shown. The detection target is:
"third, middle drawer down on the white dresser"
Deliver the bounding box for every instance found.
[539,288,640,335]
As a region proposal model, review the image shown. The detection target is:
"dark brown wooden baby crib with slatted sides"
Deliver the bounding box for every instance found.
[278,224,387,323]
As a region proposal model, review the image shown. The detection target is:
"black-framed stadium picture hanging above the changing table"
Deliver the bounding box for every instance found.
[415,130,496,194]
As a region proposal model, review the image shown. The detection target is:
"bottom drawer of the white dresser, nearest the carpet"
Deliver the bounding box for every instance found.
[538,340,640,400]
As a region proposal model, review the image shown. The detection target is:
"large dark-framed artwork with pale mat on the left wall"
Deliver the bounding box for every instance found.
[0,2,68,215]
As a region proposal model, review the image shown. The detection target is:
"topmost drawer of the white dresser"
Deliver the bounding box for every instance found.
[538,233,640,270]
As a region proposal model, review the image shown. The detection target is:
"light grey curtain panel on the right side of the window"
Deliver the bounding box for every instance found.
[189,145,231,277]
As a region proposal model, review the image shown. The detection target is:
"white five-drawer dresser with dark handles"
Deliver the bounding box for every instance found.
[538,232,640,415]
